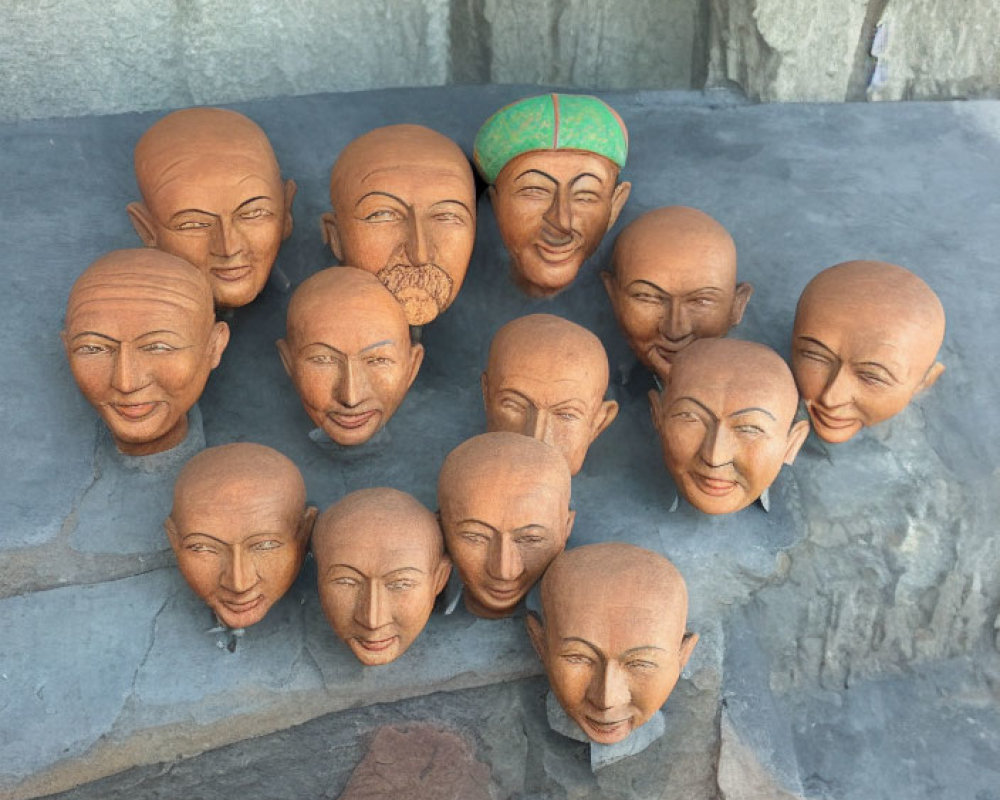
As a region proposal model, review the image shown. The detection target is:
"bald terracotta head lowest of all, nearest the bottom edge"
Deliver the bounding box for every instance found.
[527,542,698,744]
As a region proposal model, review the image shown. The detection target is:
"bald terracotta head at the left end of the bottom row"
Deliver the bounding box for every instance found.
[165,442,316,628]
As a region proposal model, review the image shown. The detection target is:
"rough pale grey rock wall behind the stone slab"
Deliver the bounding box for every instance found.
[0,0,1000,120]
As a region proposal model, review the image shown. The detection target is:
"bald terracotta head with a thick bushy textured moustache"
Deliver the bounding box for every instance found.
[323,125,476,325]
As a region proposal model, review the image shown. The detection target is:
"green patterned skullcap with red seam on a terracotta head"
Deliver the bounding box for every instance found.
[473,94,628,183]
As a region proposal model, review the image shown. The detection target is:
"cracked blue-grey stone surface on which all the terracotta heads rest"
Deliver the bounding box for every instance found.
[0,86,1000,800]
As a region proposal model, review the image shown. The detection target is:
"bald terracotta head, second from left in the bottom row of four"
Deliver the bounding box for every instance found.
[312,488,451,666]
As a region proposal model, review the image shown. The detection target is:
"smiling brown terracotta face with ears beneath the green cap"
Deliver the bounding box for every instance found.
[490,150,631,296]
